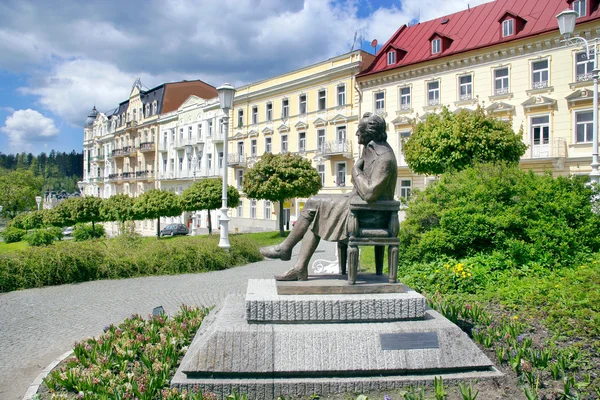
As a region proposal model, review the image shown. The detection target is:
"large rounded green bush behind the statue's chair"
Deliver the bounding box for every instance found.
[399,165,600,268]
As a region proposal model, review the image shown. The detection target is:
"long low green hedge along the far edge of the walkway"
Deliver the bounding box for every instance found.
[0,235,262,292]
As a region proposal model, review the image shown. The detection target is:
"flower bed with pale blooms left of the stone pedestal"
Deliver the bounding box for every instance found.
[44,306,214,400]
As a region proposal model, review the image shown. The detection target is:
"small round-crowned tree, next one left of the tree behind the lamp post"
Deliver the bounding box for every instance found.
[134,189,181,237]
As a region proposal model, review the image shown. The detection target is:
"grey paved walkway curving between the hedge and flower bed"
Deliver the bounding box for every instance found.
[0,242,336,400]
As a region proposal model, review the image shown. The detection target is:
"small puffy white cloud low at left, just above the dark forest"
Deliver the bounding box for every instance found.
[0,108,59,152]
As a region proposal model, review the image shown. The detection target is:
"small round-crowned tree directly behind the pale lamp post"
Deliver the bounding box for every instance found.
[181,178,240,235]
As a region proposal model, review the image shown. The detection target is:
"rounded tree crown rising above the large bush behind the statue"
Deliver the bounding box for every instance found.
[402,107,527,175]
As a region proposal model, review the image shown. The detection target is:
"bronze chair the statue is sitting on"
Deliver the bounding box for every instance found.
[338,198,400,285]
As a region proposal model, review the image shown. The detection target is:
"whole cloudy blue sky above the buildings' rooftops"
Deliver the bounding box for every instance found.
[0,0,490,154]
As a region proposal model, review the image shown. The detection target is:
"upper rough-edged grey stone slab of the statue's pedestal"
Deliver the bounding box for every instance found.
[245,279,427,324]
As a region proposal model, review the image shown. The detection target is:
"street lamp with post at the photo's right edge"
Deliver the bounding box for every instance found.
[556,9,600,185]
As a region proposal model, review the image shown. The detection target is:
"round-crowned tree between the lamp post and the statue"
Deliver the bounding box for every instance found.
[243,153,322,237]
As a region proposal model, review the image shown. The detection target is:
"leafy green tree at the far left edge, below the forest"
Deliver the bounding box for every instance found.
[0,170,44,218]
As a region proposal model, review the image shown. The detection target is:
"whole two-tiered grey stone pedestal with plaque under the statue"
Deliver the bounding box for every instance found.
[172,276,501,399]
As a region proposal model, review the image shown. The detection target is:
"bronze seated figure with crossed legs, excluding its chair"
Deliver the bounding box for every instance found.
[260,113,398,281]
